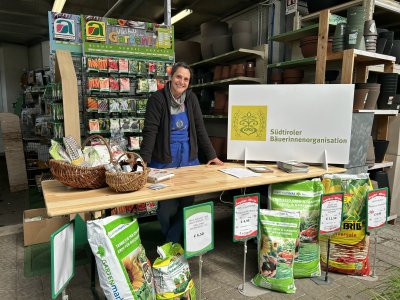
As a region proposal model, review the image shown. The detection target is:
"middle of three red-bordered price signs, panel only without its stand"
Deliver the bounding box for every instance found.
[319,193,344,235]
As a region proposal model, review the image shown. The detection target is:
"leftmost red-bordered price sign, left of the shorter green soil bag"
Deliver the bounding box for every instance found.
[233,194,260,242]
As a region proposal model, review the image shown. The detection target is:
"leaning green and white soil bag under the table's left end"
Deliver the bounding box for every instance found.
[87,215,154,300]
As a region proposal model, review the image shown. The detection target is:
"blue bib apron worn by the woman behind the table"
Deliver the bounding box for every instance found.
[149,111,200,169]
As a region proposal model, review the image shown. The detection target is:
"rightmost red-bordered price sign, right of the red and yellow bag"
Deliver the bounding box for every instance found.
[367,188,388,232]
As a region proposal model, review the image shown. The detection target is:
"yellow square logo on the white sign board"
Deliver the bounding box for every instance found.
[231,105,268,141]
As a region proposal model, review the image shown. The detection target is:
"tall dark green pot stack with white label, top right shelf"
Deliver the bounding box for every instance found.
[346,6,365,50]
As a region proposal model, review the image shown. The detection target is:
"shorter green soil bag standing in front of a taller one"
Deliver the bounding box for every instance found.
[251,209,300,293]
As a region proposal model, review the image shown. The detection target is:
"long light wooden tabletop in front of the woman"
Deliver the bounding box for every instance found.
[42,163,346,216]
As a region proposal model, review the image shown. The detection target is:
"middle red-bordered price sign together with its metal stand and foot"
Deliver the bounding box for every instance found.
[311,193,344,285]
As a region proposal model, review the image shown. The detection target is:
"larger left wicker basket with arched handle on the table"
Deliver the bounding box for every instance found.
[49,135,112,189]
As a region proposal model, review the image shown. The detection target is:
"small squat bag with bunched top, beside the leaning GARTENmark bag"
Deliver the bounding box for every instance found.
[153,243,196,300]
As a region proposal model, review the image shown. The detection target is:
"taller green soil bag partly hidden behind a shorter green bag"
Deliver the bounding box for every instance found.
[268,179,324,278]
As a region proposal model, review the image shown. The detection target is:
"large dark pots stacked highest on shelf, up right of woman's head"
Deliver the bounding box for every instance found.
[200,22,232,59]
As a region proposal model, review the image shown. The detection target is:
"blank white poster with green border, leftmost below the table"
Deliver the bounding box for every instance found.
[50,220,75,299]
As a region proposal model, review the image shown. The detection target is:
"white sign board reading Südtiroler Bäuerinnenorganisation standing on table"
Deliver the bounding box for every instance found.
[228,84,354,164]
